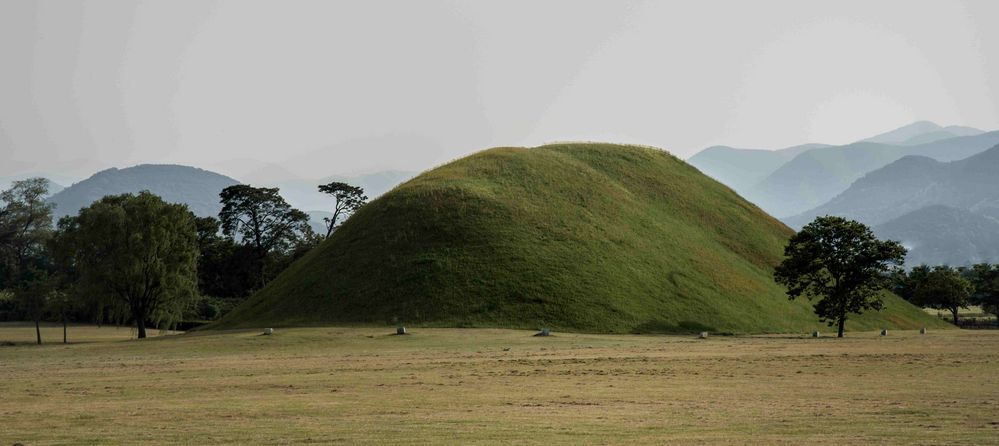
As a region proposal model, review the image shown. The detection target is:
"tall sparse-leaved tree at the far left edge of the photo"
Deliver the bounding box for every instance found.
[0,178,52,344]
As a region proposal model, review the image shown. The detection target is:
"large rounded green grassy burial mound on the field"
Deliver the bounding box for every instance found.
[217,144,939,332]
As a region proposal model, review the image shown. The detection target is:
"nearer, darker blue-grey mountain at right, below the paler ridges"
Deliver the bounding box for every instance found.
[784,145,999,265]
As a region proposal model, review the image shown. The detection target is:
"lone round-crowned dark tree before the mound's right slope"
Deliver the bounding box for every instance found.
[774,216,906,337]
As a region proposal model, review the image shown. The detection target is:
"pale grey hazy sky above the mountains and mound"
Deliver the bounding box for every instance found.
[0,0,999,179]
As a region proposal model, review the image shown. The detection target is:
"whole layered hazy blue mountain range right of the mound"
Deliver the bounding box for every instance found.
[689,121,999,265]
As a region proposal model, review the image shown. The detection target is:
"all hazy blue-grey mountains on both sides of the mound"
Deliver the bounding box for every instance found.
[15,122,999,264]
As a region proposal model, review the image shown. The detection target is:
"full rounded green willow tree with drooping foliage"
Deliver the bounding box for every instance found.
[60,191,198,338]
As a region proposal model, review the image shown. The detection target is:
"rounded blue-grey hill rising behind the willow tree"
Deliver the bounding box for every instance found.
[48,164,239,219]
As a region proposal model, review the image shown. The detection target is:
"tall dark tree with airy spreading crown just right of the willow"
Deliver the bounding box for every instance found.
[219,184,311,286]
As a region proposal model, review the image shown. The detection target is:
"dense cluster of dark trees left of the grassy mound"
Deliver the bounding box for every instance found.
[0,178,367,344]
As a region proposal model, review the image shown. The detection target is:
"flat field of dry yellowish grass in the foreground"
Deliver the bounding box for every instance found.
[0,325,999,445]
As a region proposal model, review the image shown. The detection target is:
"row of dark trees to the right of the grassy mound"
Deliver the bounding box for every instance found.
[774,215,999,337]
